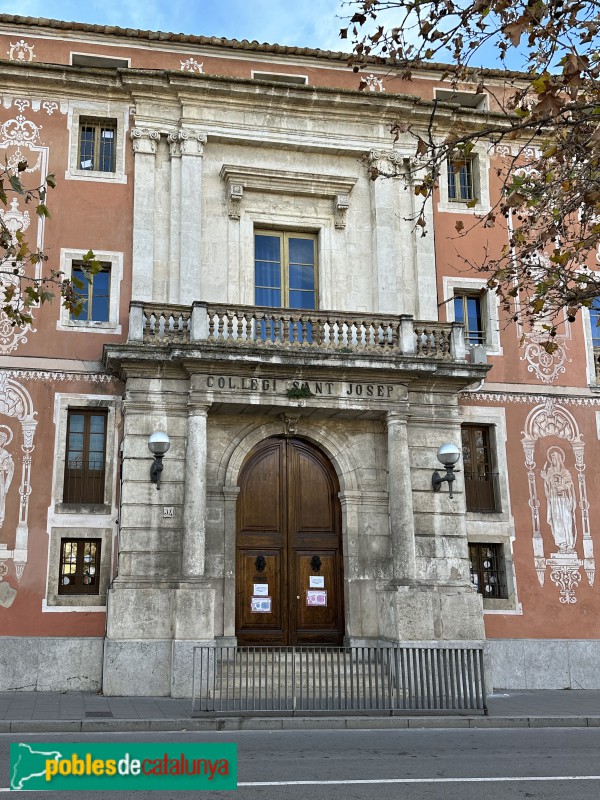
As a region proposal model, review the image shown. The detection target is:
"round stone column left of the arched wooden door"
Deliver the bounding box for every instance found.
[181,403,210,580]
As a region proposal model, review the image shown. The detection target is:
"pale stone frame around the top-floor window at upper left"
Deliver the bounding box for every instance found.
[65,101,129,184]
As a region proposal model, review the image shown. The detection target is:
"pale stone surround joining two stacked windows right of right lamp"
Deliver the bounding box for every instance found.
[459,404,523,614]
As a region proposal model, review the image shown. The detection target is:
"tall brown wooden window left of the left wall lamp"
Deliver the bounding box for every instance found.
[63,409,107,505]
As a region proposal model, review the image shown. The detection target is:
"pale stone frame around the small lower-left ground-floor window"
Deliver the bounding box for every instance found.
[42,526,114,612]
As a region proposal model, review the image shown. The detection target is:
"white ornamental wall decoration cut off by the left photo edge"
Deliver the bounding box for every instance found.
[0,371,37,607]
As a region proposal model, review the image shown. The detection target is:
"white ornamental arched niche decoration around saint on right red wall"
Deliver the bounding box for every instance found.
[522,398,595,605]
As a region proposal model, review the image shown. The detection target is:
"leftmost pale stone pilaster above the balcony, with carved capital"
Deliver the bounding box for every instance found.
[131,128,160,300]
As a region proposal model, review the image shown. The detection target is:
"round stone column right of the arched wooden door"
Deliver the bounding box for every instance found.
[387,411,415,583]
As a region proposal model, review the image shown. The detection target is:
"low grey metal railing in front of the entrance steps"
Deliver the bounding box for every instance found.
[192,645,487,715]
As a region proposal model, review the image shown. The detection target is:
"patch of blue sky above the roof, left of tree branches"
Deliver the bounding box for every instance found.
[0,0,347,50]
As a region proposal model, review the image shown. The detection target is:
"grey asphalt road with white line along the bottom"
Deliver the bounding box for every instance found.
[0,728,600,800]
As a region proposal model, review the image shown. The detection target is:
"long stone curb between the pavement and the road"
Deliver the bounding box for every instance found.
[0,716,600,734]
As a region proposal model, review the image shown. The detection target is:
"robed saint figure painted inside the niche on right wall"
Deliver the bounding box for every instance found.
[540,447,577,553]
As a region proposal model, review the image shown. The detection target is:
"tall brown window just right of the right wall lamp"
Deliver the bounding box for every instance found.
[461,425,499,512]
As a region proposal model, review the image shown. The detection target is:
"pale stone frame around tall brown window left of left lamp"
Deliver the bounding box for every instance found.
[50,393,121,516]
